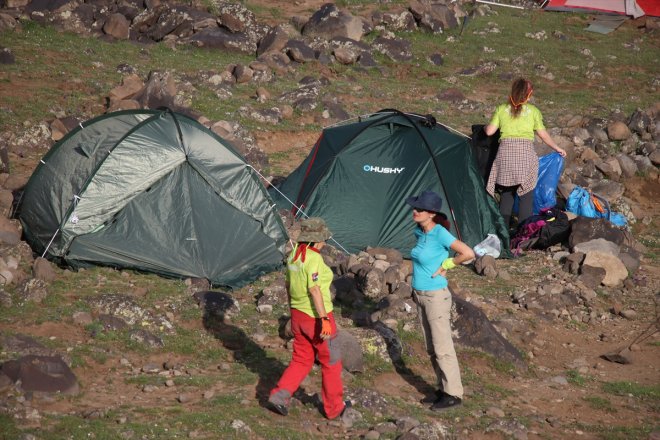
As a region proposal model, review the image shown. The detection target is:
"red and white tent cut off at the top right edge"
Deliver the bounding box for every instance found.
[544,0,660,18]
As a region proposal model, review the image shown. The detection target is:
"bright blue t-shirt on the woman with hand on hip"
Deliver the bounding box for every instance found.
[410,225,456,290]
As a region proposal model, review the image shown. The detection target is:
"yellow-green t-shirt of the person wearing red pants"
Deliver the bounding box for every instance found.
[286,244,332,318]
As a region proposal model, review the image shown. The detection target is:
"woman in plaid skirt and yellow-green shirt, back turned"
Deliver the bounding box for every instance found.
[485,78,566,226]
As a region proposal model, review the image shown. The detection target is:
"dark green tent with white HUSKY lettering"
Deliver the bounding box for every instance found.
[269,110,509,256]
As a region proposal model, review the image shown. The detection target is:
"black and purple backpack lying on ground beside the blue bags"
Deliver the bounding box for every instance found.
[511,208,571,257]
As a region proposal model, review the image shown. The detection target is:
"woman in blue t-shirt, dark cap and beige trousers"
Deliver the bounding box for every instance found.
[406,191,474,411]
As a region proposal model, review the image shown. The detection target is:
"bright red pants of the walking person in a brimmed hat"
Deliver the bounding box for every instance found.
[270,309,344,419]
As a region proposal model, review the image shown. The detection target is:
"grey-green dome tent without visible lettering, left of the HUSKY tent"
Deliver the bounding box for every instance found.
[18,109,287,286]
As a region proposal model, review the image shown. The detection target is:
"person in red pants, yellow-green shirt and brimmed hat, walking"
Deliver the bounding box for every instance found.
[268,217,346,419]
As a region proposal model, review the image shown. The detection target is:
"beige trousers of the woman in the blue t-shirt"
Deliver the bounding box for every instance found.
[413,289,463,398]
